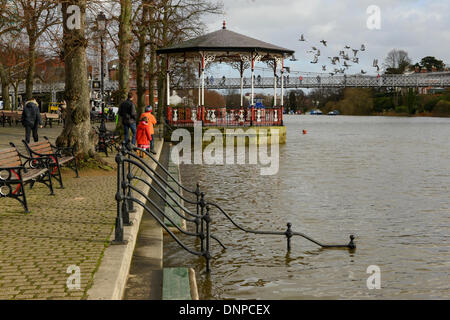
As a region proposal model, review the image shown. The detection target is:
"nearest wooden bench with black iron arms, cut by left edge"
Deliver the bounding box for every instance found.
[0,143,54,213]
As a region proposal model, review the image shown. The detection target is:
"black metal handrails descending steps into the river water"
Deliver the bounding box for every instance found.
[112,144,356,272]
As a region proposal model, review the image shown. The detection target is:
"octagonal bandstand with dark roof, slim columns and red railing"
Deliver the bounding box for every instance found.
[157,22,294,127]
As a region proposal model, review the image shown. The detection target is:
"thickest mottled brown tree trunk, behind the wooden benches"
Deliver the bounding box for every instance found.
[57,0,95,159]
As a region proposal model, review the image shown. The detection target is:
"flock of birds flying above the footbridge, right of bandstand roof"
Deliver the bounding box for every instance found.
[291,34,380,76]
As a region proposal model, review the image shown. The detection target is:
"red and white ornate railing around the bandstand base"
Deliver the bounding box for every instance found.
[167,107,283,127]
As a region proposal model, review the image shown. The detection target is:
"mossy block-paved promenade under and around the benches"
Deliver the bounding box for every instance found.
[0,125,138,299]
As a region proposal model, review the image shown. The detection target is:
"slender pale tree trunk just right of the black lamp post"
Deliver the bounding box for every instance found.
[119,0,132,103]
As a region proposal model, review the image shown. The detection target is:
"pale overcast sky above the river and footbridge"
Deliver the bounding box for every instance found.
[200,0,450,74]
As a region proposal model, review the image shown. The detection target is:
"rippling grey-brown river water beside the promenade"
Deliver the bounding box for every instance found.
[164,116,450,299]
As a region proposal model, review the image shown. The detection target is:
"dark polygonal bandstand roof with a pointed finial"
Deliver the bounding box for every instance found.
[157,23,294,57]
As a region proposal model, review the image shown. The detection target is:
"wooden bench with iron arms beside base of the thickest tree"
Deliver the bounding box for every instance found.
[22,137,79,189]
